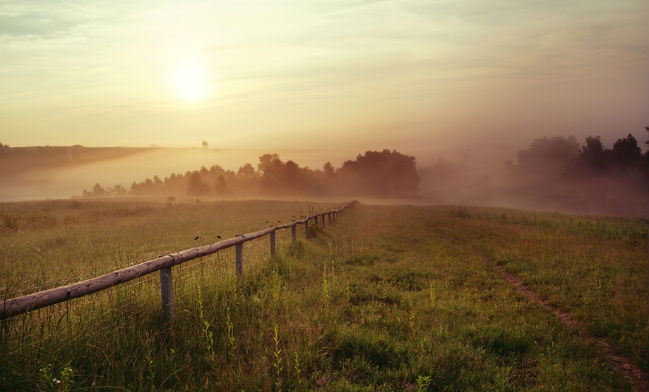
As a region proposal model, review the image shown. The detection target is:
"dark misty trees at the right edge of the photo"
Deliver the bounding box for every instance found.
[503,128,649,217]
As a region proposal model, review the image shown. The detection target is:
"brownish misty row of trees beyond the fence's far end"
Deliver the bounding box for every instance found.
[83,149,420,197]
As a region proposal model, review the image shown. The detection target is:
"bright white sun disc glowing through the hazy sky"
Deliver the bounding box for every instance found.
[171,59,210,103]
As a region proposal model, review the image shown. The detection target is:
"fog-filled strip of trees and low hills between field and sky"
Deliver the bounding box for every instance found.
[0,135,649,217]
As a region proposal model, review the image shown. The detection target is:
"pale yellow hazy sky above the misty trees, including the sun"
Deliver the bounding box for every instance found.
[0,0,649,162]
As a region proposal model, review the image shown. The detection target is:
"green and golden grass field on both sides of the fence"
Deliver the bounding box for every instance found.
[0,201,649,391]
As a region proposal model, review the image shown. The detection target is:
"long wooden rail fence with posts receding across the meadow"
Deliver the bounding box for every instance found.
[0,201,356,319]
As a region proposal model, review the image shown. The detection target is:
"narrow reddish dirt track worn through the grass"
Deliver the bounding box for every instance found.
[429,220,649,392]
